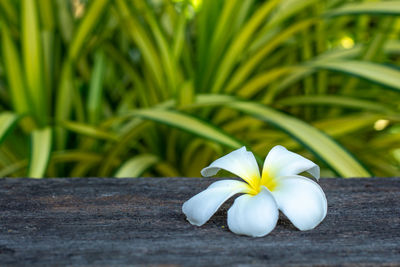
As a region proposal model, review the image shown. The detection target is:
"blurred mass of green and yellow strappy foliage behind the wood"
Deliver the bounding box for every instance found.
[0,0,400,178]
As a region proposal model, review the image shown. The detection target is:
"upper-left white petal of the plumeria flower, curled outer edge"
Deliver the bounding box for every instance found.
[201,147,260,188]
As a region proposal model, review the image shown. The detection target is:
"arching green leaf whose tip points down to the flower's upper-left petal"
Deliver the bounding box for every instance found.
[132,109,242,151]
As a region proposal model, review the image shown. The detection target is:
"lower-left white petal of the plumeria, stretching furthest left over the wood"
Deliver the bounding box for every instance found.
[182,180,249,226]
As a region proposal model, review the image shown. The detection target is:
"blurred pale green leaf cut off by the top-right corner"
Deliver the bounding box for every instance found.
[325,1,400,17]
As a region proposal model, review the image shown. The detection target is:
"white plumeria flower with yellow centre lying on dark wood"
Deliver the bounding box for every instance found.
[182,146,327,237]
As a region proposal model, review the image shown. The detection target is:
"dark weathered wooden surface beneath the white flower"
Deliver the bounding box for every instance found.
[0,178,400,266]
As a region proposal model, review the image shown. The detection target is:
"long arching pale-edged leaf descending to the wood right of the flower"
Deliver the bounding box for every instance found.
[228,102,371,177]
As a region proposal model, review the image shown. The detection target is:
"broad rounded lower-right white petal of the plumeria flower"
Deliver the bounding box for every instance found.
[272,175,328,231]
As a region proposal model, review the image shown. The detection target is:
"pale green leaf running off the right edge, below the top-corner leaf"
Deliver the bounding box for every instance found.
[310,60,400,91]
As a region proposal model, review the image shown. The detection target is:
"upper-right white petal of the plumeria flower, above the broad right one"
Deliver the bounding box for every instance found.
[263,146,319,180]
